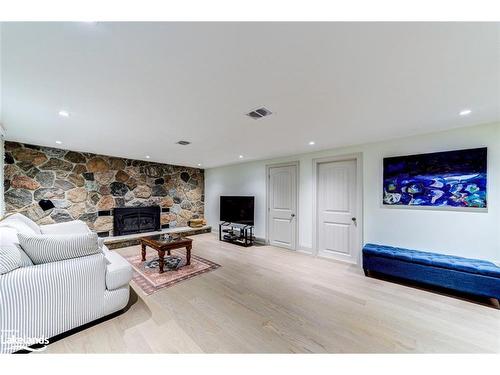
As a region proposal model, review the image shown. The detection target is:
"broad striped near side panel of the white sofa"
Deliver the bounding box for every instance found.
[0,253,106,353]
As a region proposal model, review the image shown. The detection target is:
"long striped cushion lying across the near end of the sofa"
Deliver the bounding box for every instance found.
[17,233,101,264]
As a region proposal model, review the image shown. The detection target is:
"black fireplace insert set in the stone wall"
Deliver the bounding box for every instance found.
[113,206,161,236]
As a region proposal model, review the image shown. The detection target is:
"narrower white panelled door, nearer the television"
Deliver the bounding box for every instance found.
[267,165,297,250]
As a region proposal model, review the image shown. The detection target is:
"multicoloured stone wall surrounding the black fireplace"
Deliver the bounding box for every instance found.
[4,141,204,235]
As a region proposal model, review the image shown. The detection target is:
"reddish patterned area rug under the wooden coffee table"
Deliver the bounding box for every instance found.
[125,249,220,295]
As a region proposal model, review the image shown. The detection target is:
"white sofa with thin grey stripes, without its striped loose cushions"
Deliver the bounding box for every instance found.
[0,214,132,353]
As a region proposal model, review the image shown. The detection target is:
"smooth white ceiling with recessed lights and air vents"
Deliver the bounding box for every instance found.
[2,23,500,167]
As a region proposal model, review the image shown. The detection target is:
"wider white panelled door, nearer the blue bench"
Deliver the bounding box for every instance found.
[316,160,359,263]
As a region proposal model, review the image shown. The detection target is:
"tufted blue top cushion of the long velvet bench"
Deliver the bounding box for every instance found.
[363,244,500,277]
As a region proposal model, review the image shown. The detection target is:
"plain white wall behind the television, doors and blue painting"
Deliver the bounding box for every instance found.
[205,123,500,261]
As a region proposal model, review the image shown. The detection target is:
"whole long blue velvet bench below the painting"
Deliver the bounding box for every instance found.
[363,243,500,308]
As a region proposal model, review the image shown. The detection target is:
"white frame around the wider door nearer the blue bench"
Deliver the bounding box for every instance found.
[312,152,364,266]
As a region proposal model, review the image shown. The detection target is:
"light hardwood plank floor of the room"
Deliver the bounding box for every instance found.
[46,234,500,353]
